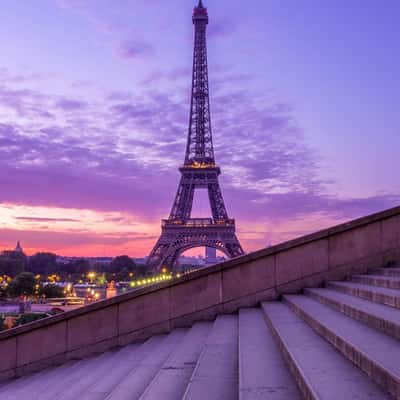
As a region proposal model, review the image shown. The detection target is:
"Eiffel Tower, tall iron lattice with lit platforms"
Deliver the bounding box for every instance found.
[147,0,244,271]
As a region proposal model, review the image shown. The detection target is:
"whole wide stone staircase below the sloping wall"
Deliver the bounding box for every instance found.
[0,267,400,400]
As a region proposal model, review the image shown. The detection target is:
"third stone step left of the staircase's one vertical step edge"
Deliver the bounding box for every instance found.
[106,329,188,400]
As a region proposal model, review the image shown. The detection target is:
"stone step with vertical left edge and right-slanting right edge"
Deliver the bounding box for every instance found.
[239,308,302,400]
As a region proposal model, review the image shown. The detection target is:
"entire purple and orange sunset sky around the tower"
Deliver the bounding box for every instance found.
[0,0,400,257]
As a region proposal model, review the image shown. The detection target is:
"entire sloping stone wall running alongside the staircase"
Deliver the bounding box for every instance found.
[0,207,400,379]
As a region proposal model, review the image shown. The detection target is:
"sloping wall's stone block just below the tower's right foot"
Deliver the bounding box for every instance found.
[222,256,275,302]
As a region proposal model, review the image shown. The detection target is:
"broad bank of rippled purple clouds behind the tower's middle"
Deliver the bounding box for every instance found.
[0,71,400,255]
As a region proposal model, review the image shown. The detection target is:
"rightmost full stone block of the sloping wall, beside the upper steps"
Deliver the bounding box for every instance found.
[329,221,382,268]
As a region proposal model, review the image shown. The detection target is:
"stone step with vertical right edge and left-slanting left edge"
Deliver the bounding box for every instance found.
[183,315,238,400]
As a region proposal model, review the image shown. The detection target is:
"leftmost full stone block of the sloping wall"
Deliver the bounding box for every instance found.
[17,321,67,367]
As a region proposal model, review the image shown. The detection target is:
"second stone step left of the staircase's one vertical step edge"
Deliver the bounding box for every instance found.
[140,322,213,400]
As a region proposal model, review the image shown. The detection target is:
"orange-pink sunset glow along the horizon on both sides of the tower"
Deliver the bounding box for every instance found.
[0,204,343,258]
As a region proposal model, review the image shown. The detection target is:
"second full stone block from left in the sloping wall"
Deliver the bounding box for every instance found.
[67,305,118,350]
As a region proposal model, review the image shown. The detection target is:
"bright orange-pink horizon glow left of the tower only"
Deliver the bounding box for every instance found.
[0,204,160,257]
